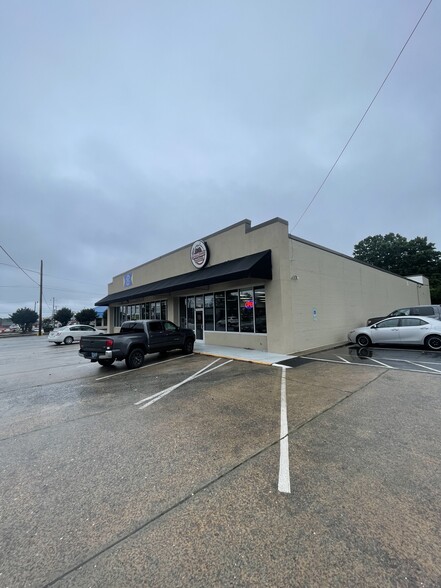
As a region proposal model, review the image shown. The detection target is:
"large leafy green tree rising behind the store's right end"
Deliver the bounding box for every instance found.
[354,233,441,304]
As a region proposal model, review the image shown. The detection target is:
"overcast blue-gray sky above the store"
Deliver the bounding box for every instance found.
[0,0,441,317]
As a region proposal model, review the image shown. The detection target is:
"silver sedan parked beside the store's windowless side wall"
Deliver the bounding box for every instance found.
[348,316,441,351]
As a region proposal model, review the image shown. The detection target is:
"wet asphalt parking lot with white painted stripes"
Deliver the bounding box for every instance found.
[0,337,441,587]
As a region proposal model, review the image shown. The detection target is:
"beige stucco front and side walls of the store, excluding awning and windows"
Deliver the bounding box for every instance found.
[104,218,430,353]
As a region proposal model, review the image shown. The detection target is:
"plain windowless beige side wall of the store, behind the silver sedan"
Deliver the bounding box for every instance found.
[282,238,430,352]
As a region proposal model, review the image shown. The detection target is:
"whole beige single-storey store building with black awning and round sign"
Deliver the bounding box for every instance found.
[96,218,430,353]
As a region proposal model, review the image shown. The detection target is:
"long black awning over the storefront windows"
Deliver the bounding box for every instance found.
[95,249,272,306]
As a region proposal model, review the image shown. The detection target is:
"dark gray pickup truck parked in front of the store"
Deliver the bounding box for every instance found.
[78,320,195,369]
